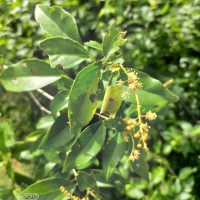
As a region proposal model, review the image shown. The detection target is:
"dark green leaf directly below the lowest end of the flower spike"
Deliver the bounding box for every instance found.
[133,150,149,181]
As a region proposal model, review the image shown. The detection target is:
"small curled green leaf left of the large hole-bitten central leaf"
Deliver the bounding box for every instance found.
[50,90,69,118]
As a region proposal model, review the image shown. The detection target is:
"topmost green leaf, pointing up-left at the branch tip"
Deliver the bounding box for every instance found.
[35,5,81,43]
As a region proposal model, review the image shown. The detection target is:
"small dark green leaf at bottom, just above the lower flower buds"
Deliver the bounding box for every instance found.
[76,171,97,191]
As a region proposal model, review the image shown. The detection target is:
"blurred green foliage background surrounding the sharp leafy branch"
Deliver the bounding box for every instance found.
[0,0,200,200]
